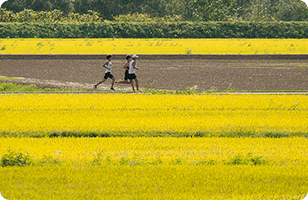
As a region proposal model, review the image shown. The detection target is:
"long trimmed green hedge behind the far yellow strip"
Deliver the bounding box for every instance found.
[0,22,308,38]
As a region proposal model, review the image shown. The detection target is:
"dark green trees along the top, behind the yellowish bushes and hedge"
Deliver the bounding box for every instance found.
[1,0,308,21]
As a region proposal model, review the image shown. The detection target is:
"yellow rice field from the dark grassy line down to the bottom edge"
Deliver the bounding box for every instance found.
[0,138,308,199]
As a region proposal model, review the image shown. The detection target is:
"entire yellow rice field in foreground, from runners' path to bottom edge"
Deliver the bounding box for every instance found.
[0,94,308,200]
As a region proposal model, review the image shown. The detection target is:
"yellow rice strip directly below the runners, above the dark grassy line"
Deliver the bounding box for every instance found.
[0,94,308,136]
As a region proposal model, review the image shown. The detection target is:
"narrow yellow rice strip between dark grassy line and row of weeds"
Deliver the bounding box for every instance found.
[0,137,308,166]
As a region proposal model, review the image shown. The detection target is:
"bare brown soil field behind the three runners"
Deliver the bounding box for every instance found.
[0,56,308,91]
